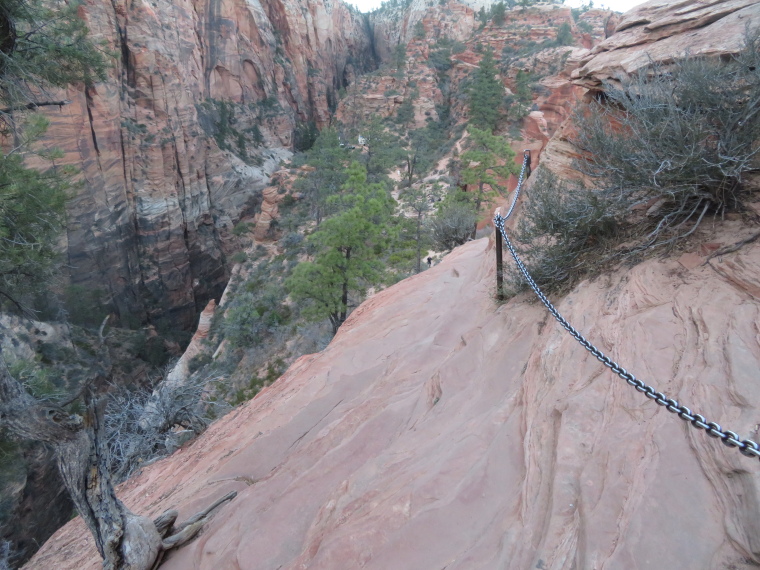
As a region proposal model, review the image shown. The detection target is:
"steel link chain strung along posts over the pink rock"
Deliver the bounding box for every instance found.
[494,150,760,459]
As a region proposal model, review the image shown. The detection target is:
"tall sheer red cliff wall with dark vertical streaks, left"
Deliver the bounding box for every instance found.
[44,0,373,328]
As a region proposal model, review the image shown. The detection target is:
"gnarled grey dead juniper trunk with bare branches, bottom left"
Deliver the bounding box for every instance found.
[0,322,236,570]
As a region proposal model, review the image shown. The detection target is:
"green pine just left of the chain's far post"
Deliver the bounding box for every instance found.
[462,127,518,237]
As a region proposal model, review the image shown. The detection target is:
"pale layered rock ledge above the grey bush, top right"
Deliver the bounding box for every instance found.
[573,0,760,89]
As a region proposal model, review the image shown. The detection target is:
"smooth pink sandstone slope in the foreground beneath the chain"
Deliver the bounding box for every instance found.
[27,232,760,570]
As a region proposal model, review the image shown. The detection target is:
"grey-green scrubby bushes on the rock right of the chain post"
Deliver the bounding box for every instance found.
[513,28,760,290]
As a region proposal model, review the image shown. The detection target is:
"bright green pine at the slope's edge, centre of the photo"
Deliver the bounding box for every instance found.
[285,162,395,333]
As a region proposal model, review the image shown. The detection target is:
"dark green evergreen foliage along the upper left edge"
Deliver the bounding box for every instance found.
[0,0,107,309]
